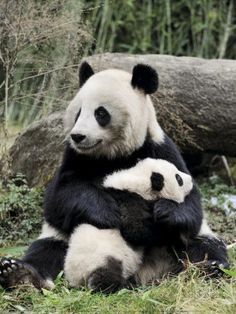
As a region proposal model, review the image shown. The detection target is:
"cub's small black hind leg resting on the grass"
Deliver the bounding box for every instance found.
[88,256,127,294]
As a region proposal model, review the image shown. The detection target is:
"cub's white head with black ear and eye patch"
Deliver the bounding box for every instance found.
[150,159,193,203]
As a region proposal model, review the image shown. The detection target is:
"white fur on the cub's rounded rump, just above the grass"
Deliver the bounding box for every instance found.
[64,224,142,287]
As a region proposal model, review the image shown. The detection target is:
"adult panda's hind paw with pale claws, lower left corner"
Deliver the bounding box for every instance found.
[0,258,45,289]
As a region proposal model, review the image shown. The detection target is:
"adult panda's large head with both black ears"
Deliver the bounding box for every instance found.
[65,62,164,158]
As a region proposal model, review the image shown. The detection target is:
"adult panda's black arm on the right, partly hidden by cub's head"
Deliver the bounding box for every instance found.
[148,135,202,237]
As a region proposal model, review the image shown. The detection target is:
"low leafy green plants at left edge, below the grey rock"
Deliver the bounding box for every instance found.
[0,175,42,246]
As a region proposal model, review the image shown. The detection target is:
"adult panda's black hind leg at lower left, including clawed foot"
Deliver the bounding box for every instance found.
[0,238,67,289]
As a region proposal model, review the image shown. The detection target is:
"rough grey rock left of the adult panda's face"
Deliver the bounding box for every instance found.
[10,112,65,186]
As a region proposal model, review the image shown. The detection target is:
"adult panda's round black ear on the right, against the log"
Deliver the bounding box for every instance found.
[131,64,158,94]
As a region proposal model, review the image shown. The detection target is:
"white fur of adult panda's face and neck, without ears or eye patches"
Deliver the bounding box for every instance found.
[65,69,164,158]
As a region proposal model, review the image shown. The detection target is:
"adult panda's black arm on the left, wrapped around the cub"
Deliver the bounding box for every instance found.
[44,172,120,234]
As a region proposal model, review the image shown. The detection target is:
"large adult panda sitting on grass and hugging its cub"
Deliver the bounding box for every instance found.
[0,63,228,288]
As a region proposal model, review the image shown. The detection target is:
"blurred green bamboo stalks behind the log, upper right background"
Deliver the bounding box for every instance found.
[87,0,236,59]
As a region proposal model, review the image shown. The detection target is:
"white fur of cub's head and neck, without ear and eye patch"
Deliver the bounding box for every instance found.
[103,158,193,203]
